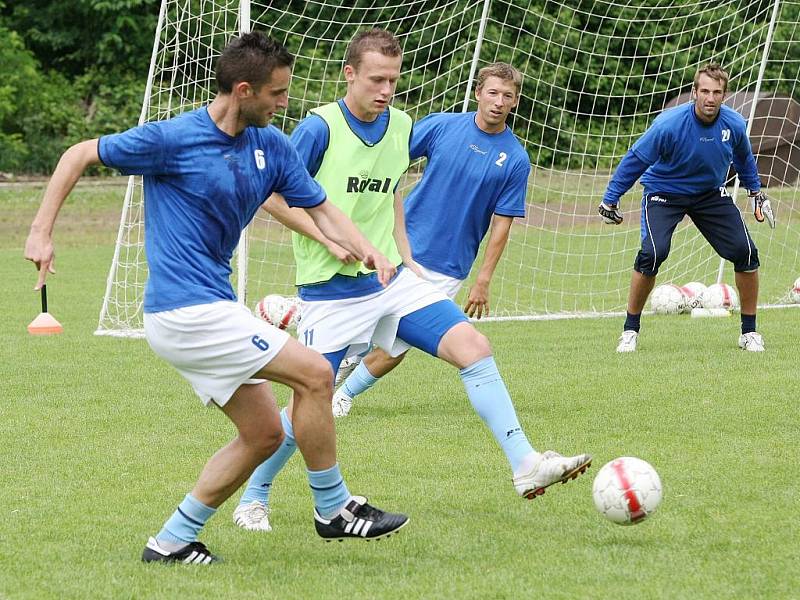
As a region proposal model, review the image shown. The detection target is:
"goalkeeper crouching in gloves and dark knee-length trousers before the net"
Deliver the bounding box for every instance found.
[598,63,775,352]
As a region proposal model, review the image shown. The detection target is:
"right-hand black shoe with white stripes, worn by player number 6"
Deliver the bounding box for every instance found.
[314,496,408,542]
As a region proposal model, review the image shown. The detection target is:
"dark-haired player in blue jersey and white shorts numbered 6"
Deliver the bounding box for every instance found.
[25,33,407,564]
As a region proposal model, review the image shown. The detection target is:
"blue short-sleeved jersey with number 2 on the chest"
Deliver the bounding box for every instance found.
[405,112,531,279]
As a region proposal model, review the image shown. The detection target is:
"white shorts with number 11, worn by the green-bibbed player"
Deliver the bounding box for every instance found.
[297,269,448,356]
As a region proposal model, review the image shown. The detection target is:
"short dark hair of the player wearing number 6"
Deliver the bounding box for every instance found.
[214,31,294,94]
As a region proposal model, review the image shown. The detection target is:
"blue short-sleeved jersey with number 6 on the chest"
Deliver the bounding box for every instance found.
[98,108,325,312]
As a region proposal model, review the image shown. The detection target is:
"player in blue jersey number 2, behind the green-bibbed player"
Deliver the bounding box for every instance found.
[333,63,530,417]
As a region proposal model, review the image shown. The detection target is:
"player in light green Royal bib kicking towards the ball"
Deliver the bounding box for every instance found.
[234,29,591,533]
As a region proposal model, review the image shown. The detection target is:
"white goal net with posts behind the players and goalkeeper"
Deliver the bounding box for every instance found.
[98,0,800,335]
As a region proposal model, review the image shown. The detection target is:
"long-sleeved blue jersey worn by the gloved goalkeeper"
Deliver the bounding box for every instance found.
[603,102,761,204]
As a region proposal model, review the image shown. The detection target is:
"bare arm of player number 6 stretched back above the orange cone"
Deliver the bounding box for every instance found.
[25,139,100,290]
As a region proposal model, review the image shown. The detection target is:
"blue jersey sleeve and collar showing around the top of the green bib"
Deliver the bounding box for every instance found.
[291,100,389,177]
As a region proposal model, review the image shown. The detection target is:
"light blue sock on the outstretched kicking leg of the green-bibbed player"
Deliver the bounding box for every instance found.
[459,356,534,471]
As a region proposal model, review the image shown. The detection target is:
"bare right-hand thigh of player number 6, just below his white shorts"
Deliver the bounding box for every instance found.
[256,338,333,393]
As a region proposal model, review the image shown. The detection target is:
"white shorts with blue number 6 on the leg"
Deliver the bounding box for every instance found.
[144,301,289,406]
